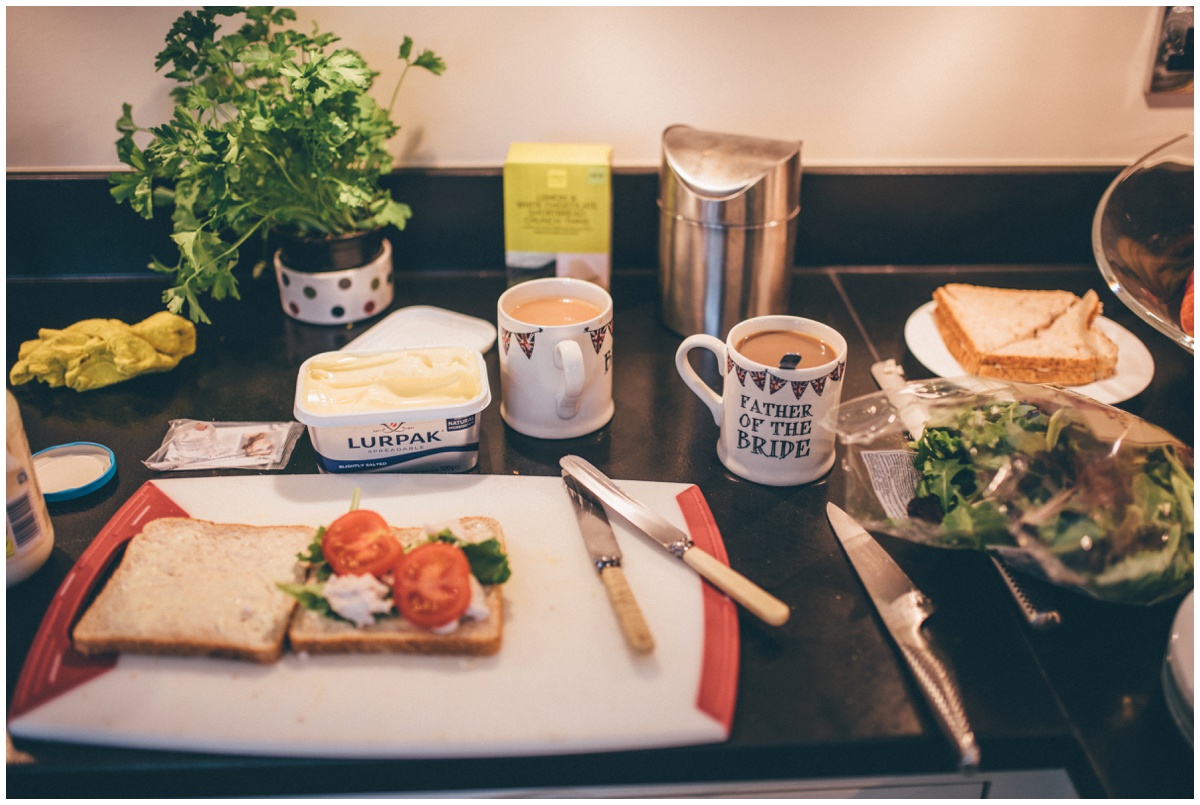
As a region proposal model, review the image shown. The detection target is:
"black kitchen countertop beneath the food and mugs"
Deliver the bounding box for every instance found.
[6,265,1195,799]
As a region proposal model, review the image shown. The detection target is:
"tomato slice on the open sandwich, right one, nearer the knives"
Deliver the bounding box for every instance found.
[391,542,470,629]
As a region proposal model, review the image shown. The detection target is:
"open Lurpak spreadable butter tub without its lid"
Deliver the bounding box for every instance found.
[294,347,492,473]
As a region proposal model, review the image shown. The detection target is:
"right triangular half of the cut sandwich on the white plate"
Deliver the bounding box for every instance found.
[978,290,1117,385]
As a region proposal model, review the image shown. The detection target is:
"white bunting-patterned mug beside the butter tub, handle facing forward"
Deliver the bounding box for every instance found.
[496,277,613,439]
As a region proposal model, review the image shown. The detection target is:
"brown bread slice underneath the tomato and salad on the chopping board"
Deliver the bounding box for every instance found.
[288,517,504,655]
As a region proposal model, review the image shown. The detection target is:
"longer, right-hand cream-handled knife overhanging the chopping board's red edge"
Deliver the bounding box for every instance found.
[558,456,792,626]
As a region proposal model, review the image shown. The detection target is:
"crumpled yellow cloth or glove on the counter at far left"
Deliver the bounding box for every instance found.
[8,311,196,391]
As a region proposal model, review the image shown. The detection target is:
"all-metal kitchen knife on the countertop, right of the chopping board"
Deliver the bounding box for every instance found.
[826,503,979,770]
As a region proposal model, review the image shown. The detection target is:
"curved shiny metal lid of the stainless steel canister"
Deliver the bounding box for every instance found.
[659,126,800,227]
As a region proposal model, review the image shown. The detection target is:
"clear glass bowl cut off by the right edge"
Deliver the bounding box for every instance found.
[1092,134,1195,354]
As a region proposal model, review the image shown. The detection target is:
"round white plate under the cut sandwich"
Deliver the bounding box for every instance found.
[904,301,1154,405]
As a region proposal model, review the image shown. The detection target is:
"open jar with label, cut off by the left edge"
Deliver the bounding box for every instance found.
[5,391,54,587]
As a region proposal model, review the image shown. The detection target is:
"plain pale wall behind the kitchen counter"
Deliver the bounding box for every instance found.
[6,6,1194,169]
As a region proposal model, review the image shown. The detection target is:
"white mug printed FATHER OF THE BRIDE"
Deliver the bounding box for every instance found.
[676,316,846,486]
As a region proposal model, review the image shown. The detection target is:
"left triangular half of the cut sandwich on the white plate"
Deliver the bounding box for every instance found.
[934,283,1078,374]
